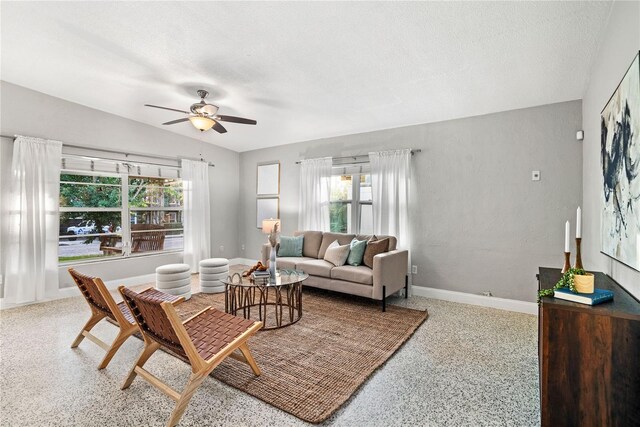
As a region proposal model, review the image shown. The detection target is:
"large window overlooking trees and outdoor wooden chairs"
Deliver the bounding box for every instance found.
[58,161,184,263]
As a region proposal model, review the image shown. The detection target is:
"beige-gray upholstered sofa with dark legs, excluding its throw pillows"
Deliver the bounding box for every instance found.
[262,231,408,311]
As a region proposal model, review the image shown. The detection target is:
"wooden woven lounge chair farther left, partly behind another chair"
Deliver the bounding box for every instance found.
[69,268,177,369]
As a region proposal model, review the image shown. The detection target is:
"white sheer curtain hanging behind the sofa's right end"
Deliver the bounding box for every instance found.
[369,149,411,278]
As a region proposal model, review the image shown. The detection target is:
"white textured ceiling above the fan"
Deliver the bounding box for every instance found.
[0,2,611,151]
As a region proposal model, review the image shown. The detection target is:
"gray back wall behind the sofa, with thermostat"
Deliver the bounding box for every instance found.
[239,101,582,301]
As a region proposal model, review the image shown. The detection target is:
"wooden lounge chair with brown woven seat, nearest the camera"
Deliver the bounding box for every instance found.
[118,286,262,427]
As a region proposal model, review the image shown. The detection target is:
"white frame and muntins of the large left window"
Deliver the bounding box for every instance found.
[58,166,184,266]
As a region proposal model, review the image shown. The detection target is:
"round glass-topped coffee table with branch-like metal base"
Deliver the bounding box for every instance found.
[223,269,309,330]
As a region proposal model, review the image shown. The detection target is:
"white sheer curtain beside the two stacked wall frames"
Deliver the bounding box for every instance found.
[298,157,332,231]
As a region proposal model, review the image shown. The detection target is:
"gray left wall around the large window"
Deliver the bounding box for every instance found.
[0,82,239,287]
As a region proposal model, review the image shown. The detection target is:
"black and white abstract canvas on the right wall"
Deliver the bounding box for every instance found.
[600,53,640,270]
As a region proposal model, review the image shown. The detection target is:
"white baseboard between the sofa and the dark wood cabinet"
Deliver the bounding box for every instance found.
[411,286,538,315]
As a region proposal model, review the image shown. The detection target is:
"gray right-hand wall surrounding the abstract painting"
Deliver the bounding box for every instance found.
[582,2,640,298]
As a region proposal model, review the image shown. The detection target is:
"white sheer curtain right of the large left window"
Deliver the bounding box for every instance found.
[182,159,211,273]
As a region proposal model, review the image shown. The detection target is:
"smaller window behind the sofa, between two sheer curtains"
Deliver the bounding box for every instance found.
[329,173,373,234]
